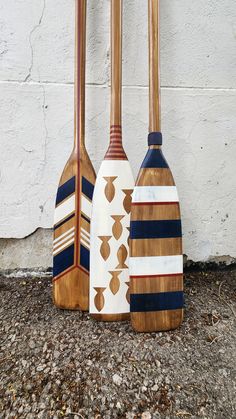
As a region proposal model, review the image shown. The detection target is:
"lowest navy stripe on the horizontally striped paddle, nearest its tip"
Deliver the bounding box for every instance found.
[130,291,184,312]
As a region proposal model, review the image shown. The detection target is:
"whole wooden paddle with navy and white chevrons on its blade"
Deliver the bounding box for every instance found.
[53,0,96,310]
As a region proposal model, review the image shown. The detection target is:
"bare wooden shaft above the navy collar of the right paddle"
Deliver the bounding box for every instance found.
[148,0,161,132]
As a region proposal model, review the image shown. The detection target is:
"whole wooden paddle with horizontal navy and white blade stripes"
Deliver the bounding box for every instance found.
[129,0,184,332]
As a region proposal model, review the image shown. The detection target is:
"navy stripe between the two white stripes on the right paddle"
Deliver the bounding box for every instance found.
[130,220,182,239]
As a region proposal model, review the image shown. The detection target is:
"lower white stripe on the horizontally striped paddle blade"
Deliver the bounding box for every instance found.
[129,255,183,276]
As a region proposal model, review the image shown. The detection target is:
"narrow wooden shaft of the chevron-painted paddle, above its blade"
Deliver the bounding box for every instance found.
[74,0,86,153]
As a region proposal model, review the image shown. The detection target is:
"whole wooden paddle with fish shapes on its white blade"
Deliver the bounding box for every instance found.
[90,0,134,321]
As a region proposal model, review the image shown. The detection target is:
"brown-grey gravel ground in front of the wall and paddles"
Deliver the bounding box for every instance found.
[0,271,236,419]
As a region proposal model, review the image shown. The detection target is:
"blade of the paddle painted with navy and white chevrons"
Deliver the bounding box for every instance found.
[53,148,96,310]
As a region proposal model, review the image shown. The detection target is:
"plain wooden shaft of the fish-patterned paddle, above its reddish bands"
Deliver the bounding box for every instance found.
[110,0,122,126]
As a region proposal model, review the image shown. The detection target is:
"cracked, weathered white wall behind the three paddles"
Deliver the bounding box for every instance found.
[0,0,236,268]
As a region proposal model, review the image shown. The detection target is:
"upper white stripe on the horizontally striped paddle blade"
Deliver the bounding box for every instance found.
[132,186,179,202]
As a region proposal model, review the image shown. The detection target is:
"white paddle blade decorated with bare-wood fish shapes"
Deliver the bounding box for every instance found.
[90,157,134,321]
